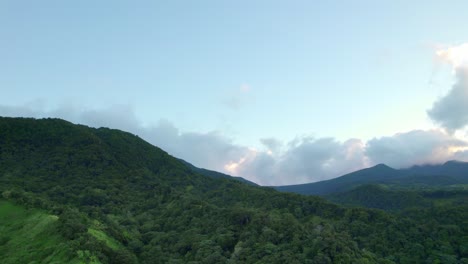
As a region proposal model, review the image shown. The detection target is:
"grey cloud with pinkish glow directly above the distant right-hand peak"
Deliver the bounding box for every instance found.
[365,130,468,168]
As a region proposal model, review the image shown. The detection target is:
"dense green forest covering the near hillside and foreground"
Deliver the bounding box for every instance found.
[0,118,468,263]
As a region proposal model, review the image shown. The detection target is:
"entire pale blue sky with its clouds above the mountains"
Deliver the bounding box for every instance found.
[0,0,468,185]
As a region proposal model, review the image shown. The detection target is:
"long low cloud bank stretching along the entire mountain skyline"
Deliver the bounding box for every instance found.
[0,102,468,185]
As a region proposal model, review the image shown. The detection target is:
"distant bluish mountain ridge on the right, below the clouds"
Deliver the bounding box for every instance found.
[274,161,468,195]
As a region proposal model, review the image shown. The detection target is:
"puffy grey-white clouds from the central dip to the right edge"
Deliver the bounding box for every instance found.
[234,129,468,185]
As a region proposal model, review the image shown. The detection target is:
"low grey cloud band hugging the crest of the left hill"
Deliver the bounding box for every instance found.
[0,101,249,174]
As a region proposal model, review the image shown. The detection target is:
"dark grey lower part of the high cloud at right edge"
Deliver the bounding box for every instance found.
[427,67,468,133]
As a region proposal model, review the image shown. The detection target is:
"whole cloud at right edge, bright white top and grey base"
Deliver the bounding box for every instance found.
[427,43,468,133]
